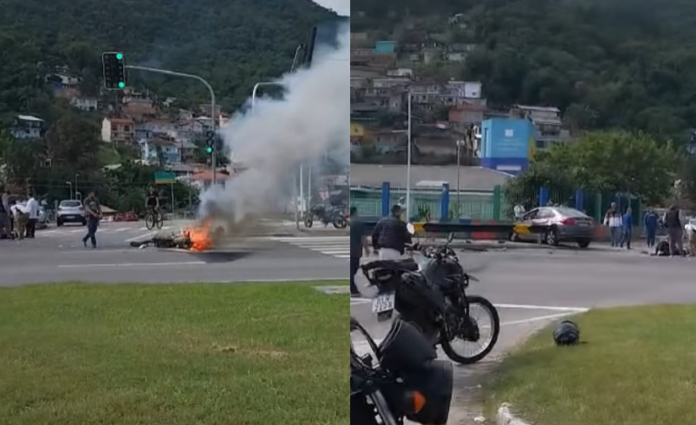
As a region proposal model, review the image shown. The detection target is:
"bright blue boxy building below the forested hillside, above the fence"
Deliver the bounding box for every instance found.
[480,118,534,174]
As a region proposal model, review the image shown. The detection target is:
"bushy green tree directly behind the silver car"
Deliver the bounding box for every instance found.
[504,131,680,208]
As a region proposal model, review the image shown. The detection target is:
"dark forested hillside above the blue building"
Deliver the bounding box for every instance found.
[351,0,696,142]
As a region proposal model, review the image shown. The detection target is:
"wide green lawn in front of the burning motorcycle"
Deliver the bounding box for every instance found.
[0,282,350,425]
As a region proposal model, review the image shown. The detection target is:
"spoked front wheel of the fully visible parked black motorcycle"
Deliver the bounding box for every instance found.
[440,295,500,364]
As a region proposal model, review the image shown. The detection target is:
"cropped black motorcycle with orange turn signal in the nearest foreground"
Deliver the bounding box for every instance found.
[350,317,453,425]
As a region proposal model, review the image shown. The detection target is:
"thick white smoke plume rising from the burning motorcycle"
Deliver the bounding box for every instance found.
[200,24,350,223]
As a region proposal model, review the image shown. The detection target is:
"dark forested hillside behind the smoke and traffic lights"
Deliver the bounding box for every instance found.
[0,0,334,114]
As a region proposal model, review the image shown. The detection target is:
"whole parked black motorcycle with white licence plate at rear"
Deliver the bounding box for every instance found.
[361,229,500,364]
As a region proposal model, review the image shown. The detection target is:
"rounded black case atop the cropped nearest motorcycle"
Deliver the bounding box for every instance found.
[379,319,437,374]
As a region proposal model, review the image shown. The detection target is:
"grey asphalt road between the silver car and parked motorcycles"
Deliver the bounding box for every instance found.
[351,247,696,425]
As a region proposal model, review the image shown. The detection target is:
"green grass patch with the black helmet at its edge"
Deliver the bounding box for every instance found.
[486,306,696,425]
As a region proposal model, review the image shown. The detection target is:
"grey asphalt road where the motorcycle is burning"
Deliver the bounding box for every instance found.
[0,223,349,286]
